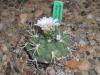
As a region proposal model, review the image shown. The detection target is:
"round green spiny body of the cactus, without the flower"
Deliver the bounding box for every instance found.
[26,26,70,63]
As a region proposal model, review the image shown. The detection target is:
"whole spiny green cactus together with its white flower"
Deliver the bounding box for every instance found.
[26,17,70,63]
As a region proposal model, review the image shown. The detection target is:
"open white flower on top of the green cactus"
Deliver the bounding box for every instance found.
[35,17,60,30]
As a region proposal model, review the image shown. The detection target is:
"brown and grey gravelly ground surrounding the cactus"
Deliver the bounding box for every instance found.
[0,0,100,75]
